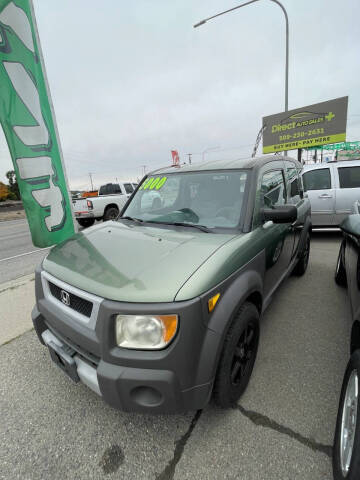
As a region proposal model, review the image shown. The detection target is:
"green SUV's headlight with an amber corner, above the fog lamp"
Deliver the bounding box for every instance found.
[115,315,178,350]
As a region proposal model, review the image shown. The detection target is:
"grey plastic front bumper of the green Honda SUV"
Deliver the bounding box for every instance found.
[32,272,219,413]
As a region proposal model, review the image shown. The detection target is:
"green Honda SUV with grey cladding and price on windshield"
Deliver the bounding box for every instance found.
[32,156,311,412]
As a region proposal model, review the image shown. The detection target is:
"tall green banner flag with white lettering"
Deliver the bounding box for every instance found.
[0,0,74,247]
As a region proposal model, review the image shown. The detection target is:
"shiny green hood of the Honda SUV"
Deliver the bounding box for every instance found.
[43,222,234,302]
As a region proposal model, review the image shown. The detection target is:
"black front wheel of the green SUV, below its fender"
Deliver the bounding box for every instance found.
[213,302,260,408]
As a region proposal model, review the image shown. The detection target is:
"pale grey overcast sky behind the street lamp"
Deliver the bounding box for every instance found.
[0,0,360,189]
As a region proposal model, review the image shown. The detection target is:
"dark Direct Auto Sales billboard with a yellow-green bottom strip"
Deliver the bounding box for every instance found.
[263,97,348,153]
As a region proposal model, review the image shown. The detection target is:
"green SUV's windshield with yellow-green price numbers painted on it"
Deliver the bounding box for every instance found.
[123,170,248,228]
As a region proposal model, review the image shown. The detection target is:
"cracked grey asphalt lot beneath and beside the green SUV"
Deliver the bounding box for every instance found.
[0,232,351,480]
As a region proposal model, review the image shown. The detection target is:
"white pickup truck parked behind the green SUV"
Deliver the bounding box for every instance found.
[73,182,137,227]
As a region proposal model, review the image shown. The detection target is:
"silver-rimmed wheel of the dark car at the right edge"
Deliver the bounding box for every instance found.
[333,350,360,480]
